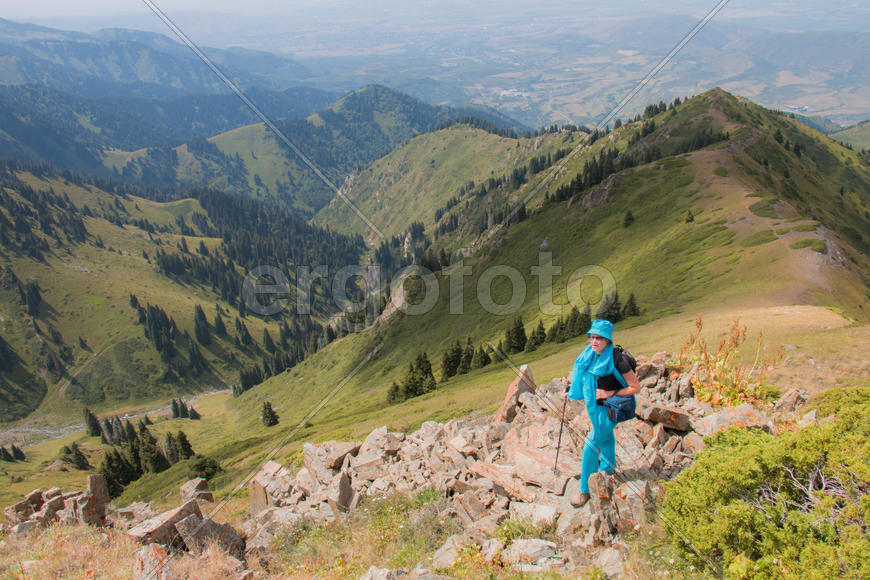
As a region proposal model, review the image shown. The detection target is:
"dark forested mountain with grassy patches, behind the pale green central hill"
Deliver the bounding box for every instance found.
[112,86,521,216]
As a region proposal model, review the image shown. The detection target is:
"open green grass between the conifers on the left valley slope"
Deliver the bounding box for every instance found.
[0,174,286,428]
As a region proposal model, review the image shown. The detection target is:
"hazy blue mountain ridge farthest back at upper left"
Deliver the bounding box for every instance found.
[0,19,310,98]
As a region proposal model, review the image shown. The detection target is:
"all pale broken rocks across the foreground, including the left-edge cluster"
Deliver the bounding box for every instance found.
[5,353,784,578]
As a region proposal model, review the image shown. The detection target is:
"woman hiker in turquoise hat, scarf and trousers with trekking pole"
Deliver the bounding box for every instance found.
[562,319,640,507]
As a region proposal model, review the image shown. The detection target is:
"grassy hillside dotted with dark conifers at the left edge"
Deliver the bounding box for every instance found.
[0,164,361,426]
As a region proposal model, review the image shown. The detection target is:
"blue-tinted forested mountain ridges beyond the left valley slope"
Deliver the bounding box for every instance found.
[0,80,527,216]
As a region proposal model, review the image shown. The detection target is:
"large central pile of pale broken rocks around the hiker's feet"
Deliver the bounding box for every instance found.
[248,353,773,577]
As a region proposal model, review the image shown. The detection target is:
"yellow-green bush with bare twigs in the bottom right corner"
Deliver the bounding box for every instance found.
[662,397,870,578]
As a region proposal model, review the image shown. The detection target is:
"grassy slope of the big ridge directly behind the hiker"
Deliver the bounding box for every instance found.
[0,93,870,516]
